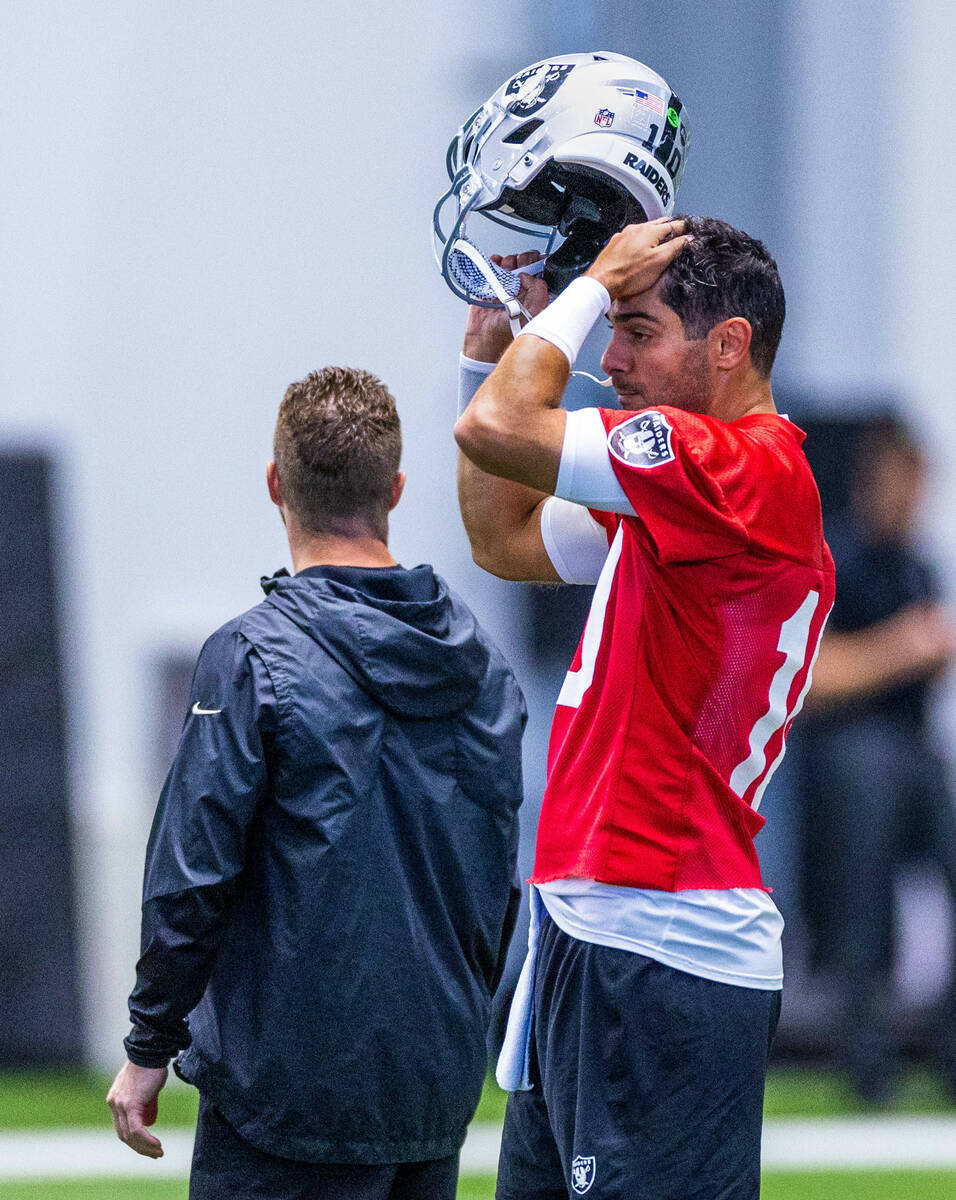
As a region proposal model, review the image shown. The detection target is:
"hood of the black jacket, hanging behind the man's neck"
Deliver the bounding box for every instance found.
[263,565,489,719]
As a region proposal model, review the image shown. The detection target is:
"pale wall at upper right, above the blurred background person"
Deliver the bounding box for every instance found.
[780,0,956,729]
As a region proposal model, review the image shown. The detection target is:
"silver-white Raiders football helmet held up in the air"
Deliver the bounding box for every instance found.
[433,53,690,324]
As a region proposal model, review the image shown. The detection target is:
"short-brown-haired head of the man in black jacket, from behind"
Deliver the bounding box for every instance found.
[273,367,402,541]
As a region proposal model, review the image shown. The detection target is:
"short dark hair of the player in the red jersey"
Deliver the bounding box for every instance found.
[660,217,787,377]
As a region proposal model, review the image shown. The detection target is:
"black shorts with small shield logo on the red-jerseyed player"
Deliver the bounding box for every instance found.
[497,916,781,1200]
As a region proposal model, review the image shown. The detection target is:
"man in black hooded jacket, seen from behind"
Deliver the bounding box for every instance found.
[108,367,525,1200]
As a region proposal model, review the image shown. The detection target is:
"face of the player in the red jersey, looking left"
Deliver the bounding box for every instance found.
[601,284,711,413]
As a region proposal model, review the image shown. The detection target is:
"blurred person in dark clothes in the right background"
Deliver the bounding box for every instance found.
[805,416,956,1102]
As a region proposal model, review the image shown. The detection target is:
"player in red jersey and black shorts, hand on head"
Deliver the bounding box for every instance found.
[455,220,834,1200]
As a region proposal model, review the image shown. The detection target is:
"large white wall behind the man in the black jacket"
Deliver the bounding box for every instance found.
[0,0,546,1066]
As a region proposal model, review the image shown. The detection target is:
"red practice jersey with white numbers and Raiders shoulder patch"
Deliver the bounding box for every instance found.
[531,407,834,892]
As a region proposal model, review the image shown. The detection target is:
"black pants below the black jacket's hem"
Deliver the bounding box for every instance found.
[190,1096,458,1200]
